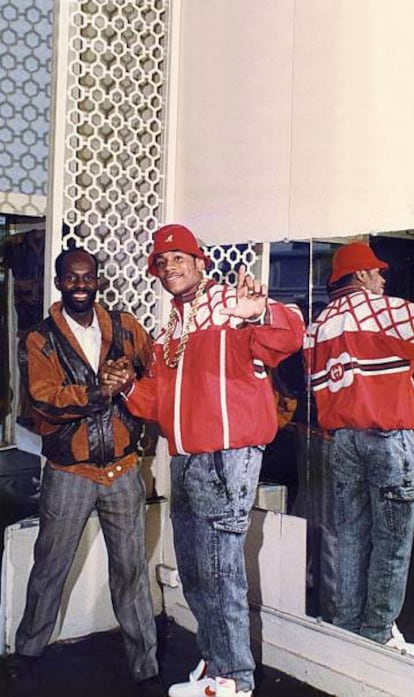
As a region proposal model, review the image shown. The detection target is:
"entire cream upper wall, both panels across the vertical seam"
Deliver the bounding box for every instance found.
[174,0,414,244]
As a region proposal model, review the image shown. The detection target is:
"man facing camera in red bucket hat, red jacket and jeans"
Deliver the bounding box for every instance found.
[103,225,304,697]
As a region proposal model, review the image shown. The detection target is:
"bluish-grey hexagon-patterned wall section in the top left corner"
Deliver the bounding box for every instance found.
[0,0,53,201]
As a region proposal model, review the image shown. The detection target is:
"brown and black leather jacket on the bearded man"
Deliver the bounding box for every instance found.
[18,302,151,468]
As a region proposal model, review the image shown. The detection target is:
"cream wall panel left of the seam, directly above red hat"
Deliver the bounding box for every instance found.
[174,0,294,244]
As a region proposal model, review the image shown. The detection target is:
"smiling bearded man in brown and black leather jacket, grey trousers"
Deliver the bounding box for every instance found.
[5,248,164,697]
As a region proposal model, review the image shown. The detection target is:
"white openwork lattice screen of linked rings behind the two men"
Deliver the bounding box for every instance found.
[54,0,257,331]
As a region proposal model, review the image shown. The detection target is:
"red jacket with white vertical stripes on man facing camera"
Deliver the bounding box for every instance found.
[127,284,304,455]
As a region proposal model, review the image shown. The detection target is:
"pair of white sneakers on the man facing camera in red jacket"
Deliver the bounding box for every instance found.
[168,659,252,697]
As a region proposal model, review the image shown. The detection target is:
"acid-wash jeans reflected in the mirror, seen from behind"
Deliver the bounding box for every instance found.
[330,429,414,643]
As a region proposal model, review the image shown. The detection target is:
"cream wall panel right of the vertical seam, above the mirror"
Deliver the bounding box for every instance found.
[289,0,414,237]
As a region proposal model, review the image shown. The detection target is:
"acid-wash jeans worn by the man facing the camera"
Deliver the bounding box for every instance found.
[171,447,262,690]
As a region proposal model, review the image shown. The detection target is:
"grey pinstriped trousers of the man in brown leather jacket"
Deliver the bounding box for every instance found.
[16,465,158,680]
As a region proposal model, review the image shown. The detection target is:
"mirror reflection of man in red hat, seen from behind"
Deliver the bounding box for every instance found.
[306,242,414,655]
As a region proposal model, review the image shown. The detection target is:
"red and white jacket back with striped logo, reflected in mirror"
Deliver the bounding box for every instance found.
[305,289,414,431]
